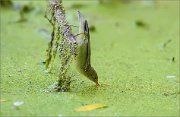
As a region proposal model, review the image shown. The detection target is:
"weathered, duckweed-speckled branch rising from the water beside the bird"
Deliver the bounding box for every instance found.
[45,0,77,92]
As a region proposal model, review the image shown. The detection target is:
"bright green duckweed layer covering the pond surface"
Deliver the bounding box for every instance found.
[0,1,180,116]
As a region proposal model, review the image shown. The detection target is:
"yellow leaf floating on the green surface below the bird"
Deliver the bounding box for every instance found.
[75,104,107,112]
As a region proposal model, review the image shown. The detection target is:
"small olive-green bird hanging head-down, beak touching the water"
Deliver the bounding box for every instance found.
[75,11,99,86]
